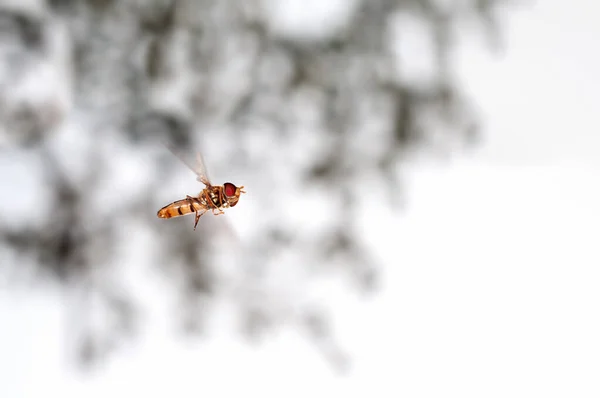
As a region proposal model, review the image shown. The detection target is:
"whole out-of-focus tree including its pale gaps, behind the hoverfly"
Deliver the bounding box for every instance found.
[0,0,508,372]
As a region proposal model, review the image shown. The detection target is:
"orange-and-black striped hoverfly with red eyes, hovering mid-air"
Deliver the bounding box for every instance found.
[156,145,246,231]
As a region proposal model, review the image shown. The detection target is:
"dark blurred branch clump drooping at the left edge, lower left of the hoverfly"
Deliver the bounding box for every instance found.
[0,145,142,363]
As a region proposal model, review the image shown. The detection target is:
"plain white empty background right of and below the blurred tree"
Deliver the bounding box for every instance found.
[0,0,600,398]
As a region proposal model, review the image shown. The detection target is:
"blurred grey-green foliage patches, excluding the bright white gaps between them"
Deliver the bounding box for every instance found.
[0,0,508,372]
